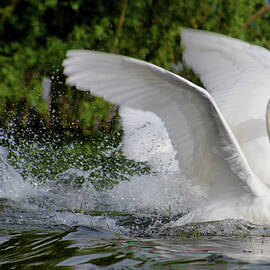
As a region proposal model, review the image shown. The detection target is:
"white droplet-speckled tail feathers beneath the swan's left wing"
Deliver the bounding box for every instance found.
[120,107,179,175]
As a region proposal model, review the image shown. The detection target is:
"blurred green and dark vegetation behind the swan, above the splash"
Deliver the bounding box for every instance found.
[0,0,270,188]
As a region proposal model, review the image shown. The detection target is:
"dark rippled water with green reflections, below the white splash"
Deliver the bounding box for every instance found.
[0,226,270,269]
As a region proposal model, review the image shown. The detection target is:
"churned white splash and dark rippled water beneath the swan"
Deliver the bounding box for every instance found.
[0,123,270,269]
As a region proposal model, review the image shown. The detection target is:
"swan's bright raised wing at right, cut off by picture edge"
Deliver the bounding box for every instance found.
[181,29,270,186]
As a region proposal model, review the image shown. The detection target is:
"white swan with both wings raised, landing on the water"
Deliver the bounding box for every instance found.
[63,28,270,224]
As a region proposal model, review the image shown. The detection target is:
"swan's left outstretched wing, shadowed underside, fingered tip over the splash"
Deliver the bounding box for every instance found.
[63,50,261,195]
